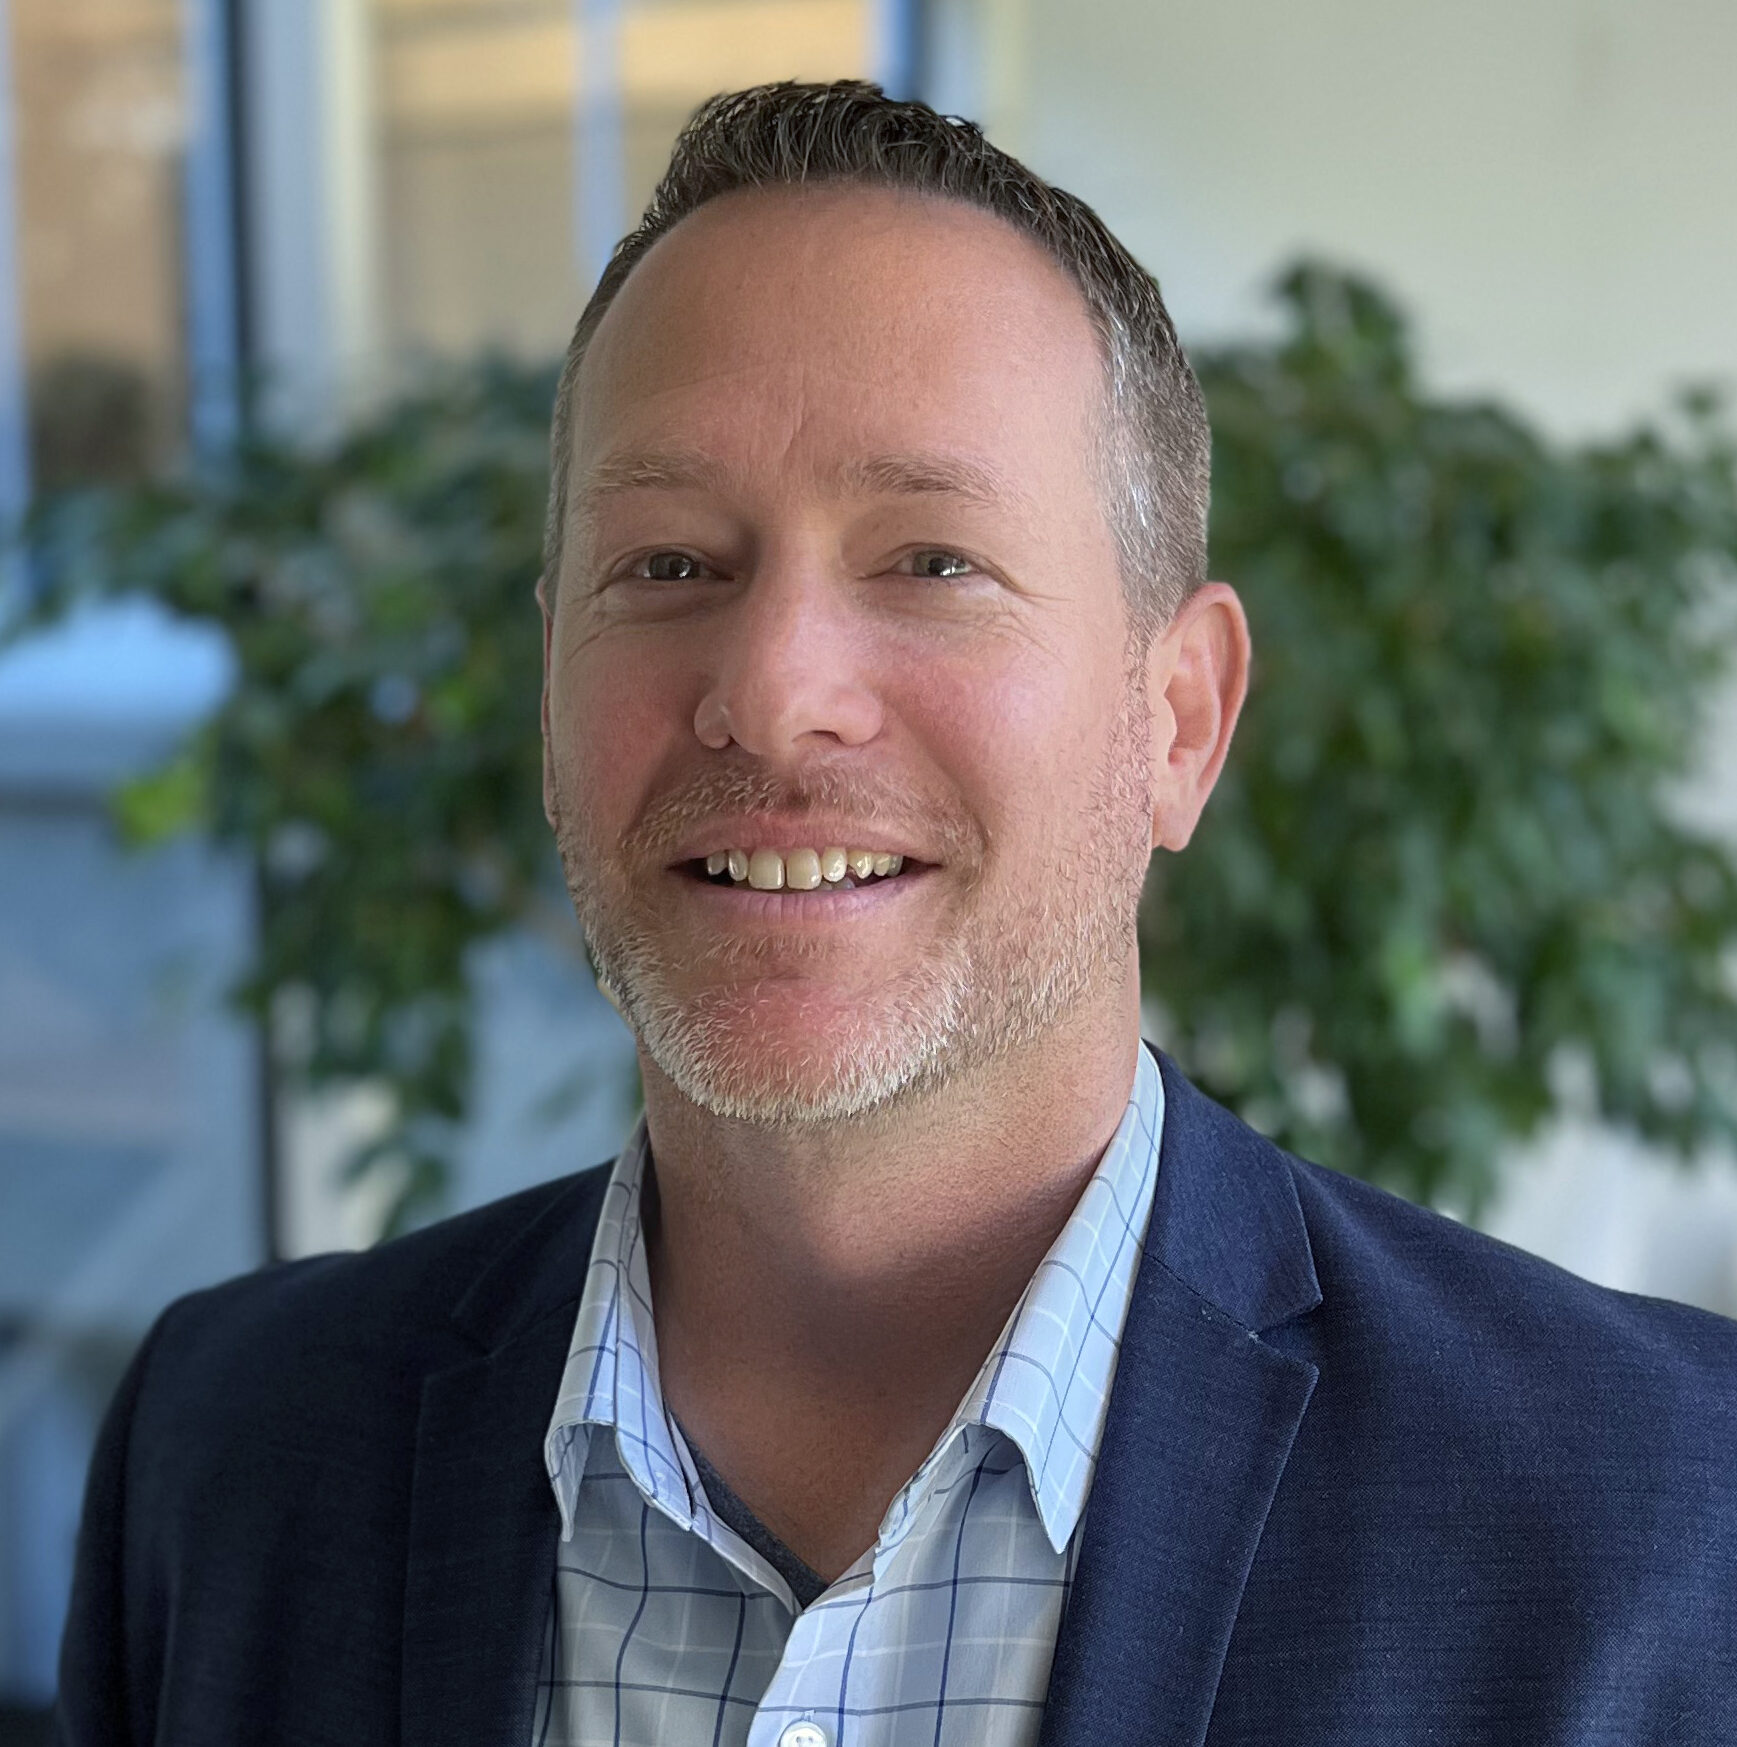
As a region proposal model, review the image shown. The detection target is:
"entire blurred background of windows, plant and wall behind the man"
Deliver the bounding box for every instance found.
[0,0,1737,1719]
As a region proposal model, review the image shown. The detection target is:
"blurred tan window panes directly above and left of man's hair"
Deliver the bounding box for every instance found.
[374,0,874,356]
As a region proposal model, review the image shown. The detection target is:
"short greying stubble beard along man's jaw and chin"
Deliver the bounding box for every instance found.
[556,676,1152,1129]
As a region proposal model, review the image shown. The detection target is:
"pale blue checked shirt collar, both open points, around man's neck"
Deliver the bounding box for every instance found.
[543,1048,1164,1553]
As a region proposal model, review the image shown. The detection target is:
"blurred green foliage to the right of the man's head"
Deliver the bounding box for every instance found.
[1143,267,1737,1211]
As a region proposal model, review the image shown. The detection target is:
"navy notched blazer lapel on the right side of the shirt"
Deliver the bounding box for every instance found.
[1040,1057,1321,1747]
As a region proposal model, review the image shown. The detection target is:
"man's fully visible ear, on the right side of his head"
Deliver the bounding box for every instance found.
[1146,582,1249,849]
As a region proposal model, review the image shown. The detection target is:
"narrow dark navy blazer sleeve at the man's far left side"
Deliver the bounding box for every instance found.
[54,1312,168,1747]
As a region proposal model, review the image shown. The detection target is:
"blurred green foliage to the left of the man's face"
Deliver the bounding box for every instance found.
[20,363,569,1226]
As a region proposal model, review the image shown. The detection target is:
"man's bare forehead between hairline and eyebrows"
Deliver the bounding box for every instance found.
[573,187,1104,477]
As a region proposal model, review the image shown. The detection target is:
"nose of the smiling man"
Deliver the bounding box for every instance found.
[694,563,881,760]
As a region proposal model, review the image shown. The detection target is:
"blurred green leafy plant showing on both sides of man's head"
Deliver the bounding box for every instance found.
[13,267,1737,1223]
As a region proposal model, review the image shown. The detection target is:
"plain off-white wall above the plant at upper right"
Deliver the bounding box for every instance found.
[984,0,1737,430]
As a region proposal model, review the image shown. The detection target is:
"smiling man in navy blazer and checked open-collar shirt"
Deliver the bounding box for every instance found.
[63,84,1737,1747]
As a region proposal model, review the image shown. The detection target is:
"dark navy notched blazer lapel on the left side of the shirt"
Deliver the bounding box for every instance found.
[402,1170,608,1747]
